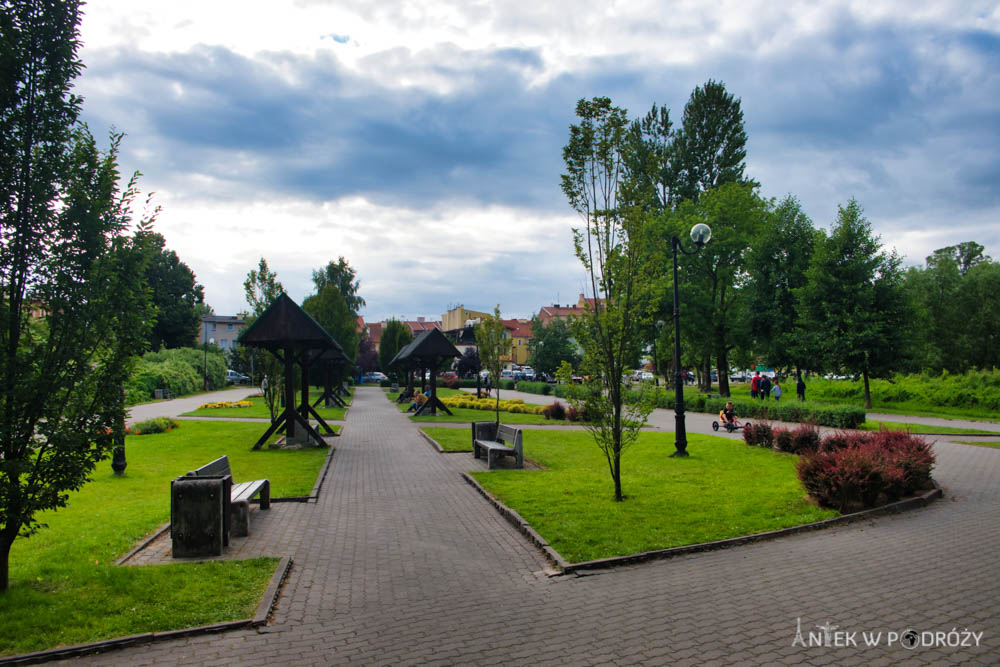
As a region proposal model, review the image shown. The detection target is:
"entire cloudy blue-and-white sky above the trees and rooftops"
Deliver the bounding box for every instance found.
[77,0,1000,321]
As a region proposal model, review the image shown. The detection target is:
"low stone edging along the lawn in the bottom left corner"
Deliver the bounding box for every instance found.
[0,556,292,665]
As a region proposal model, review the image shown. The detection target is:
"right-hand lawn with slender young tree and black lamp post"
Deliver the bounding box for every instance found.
[463,430,837,562]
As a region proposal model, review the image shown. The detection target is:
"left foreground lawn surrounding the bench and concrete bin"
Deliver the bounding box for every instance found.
[0,421,328,655]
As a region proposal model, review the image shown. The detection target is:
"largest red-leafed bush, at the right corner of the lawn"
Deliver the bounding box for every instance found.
[797,431,935,512]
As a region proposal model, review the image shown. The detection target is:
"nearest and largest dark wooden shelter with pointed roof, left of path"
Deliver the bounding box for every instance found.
[239,293,343,449]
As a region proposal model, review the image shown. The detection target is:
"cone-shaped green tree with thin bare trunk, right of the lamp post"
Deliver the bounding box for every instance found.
[799,199,911,408]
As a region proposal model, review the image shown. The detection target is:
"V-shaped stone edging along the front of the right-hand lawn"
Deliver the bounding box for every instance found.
[462,473,944,574]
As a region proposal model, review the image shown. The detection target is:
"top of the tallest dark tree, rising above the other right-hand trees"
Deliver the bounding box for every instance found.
[673,79,747,200]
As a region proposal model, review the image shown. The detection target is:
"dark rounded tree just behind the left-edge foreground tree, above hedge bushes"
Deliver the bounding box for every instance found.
[146,234,205,350]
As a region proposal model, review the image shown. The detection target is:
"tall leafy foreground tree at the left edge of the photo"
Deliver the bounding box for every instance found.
[0,0,155,590]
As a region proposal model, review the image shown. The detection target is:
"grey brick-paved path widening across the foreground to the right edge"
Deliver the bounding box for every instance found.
[80,389,1000,665]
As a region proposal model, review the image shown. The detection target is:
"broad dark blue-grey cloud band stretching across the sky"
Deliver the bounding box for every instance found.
[80,11,1000,264]
